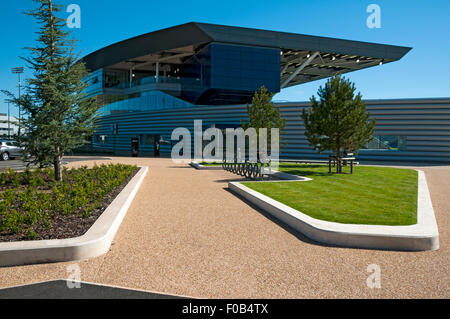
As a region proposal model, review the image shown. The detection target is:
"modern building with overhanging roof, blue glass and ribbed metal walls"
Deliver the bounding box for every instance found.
[83,23,450,161]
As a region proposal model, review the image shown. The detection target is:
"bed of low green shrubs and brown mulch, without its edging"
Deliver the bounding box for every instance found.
[0,164,138,242]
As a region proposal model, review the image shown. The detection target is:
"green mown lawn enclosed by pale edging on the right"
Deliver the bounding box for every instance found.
[243,163,417,225]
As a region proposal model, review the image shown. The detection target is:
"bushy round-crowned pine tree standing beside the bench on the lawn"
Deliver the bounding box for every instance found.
[302,76,375,172]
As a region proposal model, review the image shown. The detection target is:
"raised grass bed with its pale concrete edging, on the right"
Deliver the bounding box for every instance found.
[228,164,439,251]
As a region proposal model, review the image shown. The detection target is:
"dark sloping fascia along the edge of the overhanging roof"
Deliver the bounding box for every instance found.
[83,22,411,70]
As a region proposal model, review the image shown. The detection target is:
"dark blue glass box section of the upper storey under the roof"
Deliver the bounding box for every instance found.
[179,42,280,105]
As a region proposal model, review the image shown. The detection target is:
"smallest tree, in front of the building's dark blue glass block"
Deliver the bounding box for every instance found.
[241,86,286,160]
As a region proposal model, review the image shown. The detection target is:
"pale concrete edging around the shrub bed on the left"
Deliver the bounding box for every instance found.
[0,167,148,266]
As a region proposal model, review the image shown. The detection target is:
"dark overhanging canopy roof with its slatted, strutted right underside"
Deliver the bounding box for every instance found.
[83,22,411,88]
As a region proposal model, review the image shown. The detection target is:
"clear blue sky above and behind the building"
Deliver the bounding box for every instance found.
[0,0,450,114]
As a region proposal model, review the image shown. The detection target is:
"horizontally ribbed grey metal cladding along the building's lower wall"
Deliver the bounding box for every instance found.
[94,98,450,163]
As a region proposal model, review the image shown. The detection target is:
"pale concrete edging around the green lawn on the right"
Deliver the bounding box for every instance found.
[228,170,439,251]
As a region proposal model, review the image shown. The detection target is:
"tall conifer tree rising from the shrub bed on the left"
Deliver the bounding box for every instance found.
[3,0,97,181]
